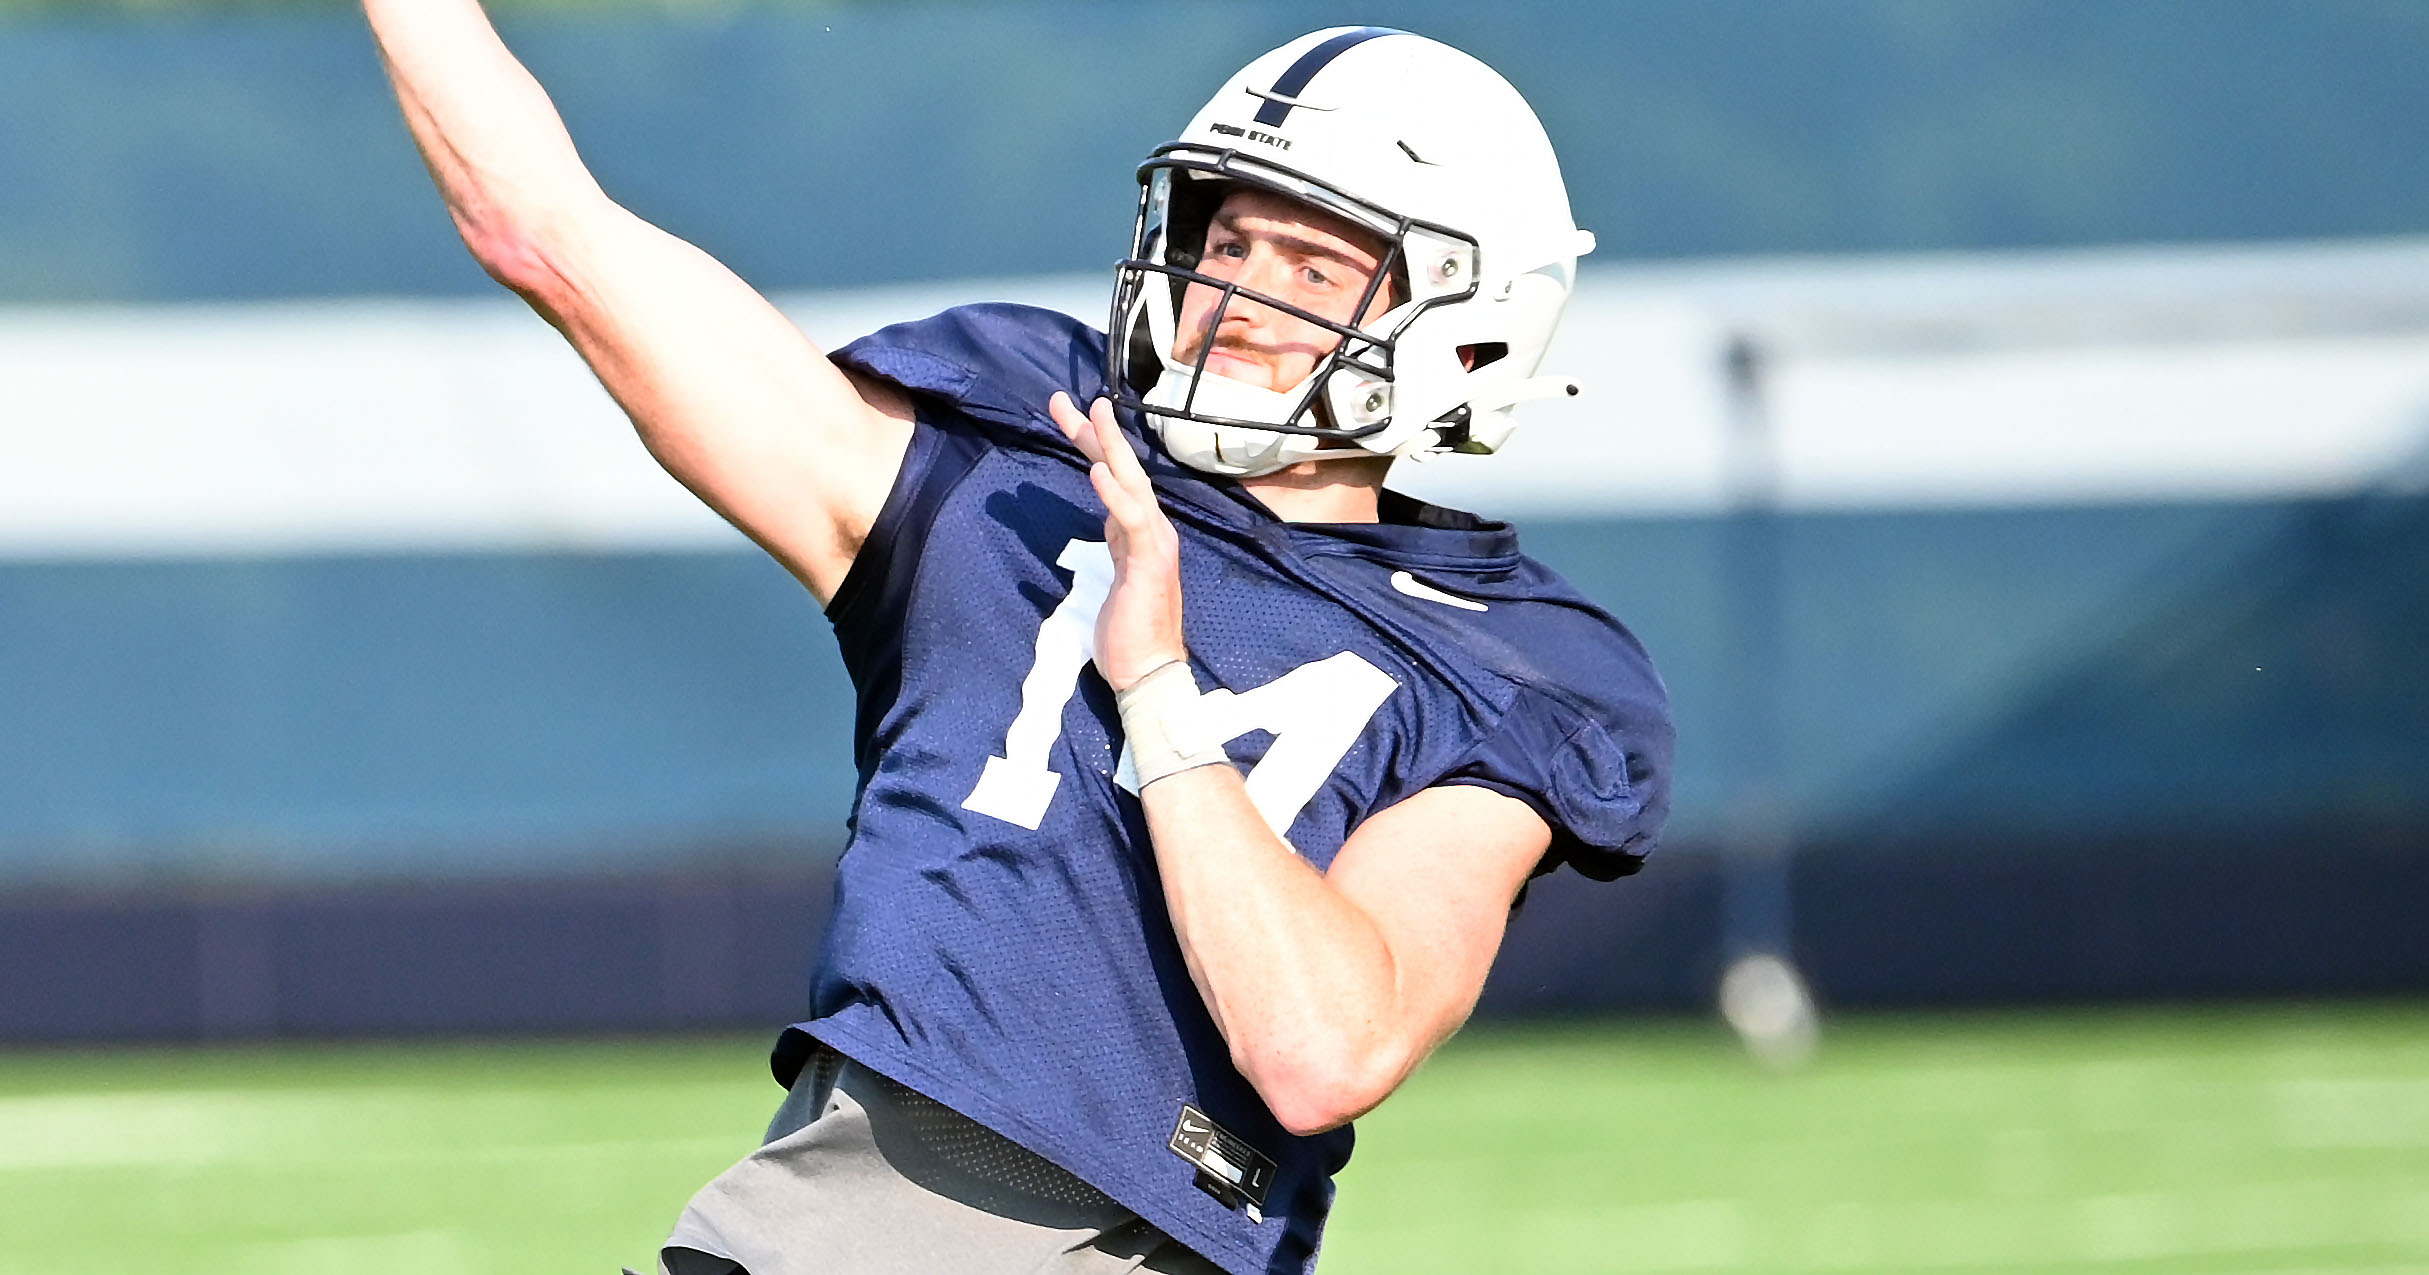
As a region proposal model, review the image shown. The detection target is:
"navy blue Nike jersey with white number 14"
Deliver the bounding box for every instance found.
[777,306,1671,1275]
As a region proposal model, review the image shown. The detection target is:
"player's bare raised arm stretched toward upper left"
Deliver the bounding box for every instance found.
[364,0,911,602]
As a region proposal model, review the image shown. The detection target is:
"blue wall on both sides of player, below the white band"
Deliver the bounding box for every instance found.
[0,498,2429,882]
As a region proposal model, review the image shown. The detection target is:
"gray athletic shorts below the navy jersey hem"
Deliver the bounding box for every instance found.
[658,1052,1222,1275]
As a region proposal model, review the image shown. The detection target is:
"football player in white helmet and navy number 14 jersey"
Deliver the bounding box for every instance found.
[367,12,1671,1275]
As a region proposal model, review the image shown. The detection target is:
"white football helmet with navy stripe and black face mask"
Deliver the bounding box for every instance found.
[1108,27,1593,476]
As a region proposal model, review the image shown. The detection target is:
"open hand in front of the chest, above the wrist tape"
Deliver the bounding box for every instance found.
[1047,391,1188,690]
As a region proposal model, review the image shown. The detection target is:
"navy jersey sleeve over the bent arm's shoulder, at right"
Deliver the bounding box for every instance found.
[1440,687,1671,882]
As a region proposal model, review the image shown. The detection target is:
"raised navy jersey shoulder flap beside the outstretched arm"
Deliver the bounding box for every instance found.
[836,301,1105,427]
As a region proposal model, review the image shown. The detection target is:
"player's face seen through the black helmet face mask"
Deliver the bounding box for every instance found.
[1173,187,1389,389]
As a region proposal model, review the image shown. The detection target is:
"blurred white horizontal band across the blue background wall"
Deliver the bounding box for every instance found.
[14,240,2429,559]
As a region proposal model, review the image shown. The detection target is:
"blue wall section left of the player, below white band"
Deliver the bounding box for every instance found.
[0,554,853,879]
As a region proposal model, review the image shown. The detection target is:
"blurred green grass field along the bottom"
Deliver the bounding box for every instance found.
[0,1003,2429,1275]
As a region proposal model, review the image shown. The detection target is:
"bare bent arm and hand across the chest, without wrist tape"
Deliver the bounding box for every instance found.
[1052,396,1552,1134]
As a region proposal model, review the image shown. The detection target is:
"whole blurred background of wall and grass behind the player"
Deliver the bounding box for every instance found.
[0,0,2429,1273]
